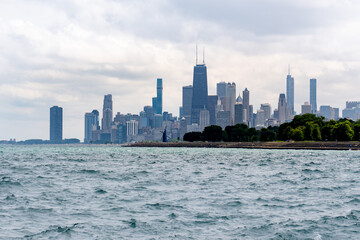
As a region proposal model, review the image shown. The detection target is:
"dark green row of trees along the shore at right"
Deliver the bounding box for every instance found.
[183,114,360,142]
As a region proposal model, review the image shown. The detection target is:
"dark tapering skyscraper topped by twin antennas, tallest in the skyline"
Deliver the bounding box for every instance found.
[191,54,208,124]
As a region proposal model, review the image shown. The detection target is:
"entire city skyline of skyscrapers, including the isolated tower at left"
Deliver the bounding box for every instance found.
[40,49,360,143]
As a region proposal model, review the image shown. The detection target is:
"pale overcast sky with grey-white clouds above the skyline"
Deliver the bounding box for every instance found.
[0,0,360,140]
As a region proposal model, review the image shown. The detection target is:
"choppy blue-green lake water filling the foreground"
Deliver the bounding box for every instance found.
[0,146,360,240]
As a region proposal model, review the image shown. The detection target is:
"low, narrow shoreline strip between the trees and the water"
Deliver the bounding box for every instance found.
[124,142,360,150]
